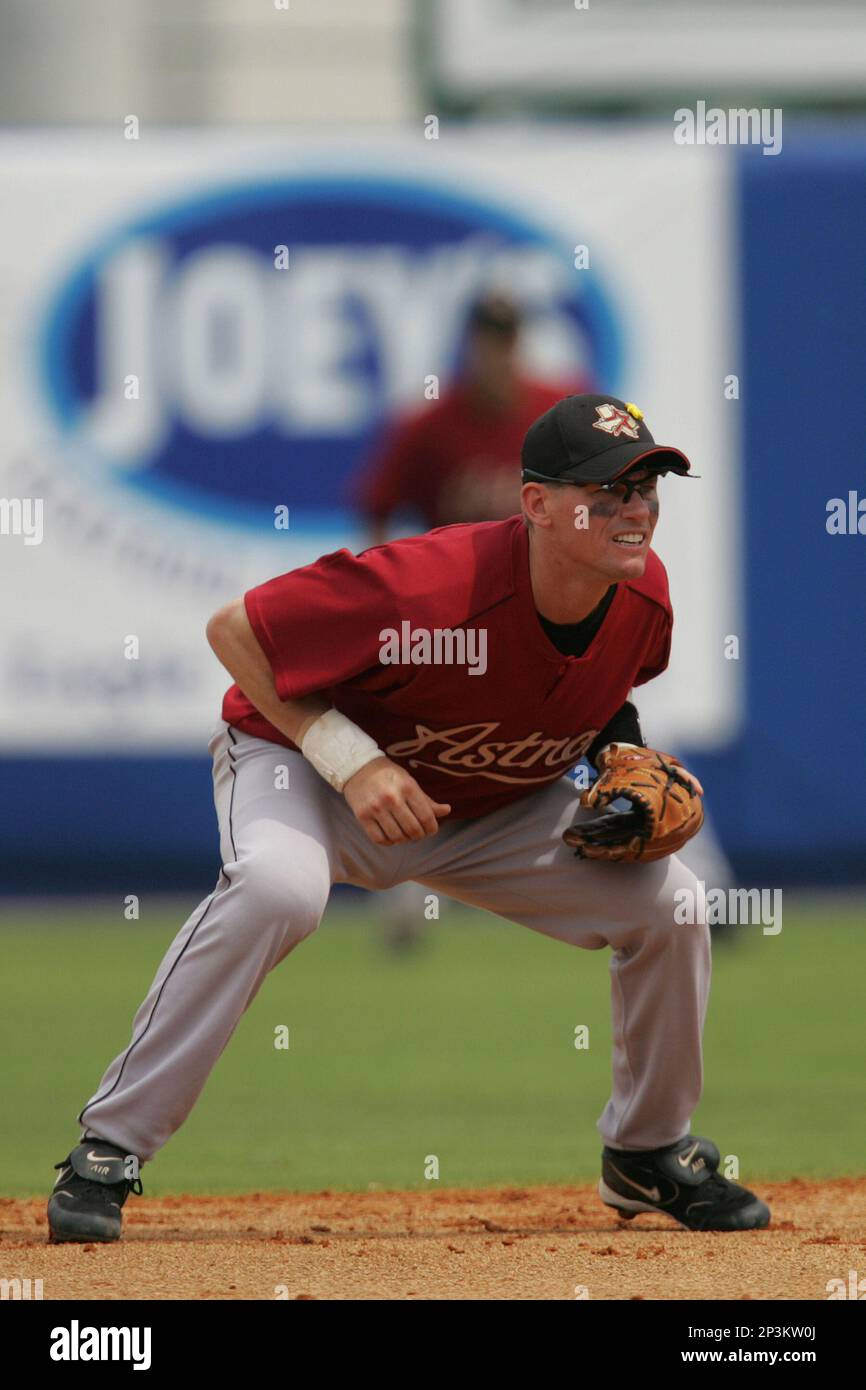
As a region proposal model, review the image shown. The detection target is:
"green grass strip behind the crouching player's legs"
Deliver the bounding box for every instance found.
[0,895,866,1195]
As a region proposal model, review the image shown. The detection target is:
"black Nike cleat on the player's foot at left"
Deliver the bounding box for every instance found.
[49,1138,142,1243]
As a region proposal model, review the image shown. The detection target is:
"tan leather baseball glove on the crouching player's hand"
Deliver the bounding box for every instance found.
[563,744,703,863]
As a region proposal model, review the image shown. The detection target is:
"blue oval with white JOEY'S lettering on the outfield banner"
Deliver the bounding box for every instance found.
[40,177,620,528]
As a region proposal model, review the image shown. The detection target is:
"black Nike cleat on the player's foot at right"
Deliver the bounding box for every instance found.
[598,1134,770,1230]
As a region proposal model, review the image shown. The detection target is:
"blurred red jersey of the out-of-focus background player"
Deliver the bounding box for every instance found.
[356,378,575,527]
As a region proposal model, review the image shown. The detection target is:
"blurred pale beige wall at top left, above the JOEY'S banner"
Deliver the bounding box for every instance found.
[0,0,414,125]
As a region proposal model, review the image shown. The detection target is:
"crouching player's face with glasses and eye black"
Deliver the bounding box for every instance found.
[556,475,659,581]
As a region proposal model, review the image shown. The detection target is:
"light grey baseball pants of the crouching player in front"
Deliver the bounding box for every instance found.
[79,721,710,1162]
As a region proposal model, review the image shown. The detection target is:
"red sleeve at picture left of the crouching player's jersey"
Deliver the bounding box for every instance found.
[243,548,396,699]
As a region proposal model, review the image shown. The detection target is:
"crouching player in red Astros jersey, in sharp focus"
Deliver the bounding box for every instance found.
[49,395,770,1241]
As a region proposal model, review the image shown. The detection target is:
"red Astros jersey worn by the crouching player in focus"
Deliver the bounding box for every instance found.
[222,516,673,817]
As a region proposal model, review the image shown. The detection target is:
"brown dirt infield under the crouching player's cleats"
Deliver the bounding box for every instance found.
[0,1179,866,1300]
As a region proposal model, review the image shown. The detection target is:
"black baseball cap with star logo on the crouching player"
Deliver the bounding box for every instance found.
[521,396,694,482]
